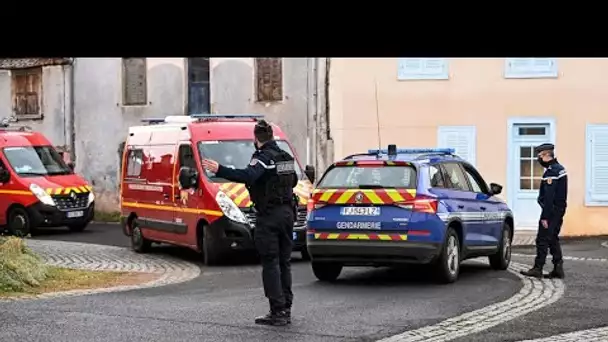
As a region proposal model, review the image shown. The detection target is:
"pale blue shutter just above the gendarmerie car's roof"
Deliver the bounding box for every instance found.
[437,126,477,165]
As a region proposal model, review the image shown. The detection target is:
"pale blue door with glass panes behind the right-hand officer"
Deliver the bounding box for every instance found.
[507,119,555,230]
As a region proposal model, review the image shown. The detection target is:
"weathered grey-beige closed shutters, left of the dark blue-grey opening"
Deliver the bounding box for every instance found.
[122,58,148,106]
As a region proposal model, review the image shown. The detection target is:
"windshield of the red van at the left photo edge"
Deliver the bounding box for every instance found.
[4,146,72,177]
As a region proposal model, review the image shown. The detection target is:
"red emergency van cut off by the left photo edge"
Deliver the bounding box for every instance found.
[0,123,95,236]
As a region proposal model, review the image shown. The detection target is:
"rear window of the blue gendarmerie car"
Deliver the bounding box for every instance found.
[317,166,416,189]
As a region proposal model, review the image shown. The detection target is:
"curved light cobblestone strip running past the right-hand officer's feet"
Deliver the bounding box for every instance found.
[378,262,564,342]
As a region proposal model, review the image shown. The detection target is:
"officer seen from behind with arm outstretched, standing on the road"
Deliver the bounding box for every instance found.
[202,120,298,325]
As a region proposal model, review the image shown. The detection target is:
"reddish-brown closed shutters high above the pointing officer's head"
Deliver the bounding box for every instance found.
[255,58,283,102]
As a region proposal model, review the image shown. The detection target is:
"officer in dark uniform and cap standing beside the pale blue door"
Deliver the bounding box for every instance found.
[521,144,568,278]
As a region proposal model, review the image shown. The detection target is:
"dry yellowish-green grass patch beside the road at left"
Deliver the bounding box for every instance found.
[0,237,157,297]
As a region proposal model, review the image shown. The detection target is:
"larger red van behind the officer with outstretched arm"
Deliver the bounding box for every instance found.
[121,114,314,265]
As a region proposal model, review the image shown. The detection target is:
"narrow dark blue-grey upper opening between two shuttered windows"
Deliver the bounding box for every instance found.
[188,57,211,115]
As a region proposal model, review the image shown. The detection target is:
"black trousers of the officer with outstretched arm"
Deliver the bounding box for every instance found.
[254,205,294,312]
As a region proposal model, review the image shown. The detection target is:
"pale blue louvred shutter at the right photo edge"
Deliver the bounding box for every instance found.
[585,125,608,206]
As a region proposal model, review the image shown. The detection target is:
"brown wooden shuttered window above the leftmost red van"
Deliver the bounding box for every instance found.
[11,68,42,119]
